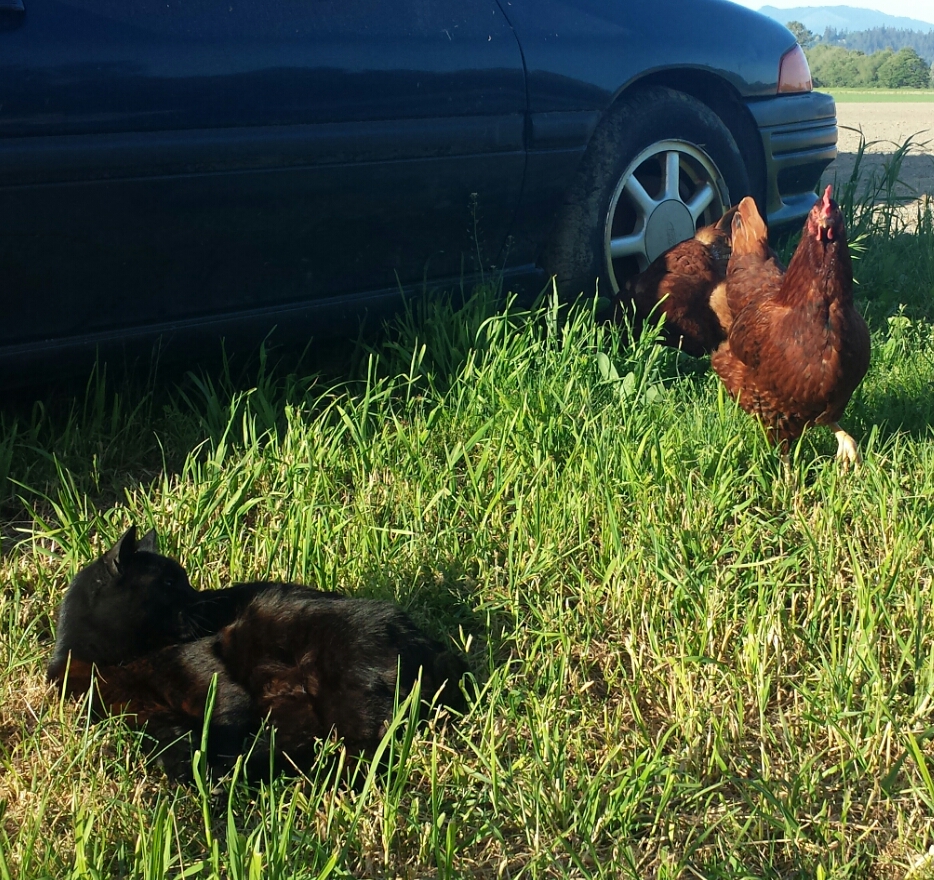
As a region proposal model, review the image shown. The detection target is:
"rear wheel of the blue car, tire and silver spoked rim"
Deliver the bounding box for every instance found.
[542,86,750,298]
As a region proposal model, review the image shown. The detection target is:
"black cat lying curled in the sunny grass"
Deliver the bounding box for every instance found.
[48,526,467,775]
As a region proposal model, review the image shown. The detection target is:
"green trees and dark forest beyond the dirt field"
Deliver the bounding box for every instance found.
[787,21,934,89]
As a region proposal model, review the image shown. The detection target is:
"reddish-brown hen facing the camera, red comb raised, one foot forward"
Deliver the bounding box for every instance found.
[711,186,870,463]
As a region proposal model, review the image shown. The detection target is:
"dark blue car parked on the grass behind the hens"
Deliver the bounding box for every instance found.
[0,0,837,381]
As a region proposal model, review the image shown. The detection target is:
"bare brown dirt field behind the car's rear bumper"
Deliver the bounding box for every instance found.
[822,101,934,204]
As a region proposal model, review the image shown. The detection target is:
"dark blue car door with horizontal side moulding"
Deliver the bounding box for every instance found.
[0,0,525,344]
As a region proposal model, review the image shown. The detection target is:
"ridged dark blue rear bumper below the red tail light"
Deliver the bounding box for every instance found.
[746,92,837,232]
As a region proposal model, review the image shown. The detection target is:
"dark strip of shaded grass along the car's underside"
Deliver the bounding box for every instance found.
[0,292,482,532]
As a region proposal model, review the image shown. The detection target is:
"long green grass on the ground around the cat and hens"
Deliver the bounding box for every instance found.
[0,148,934,880]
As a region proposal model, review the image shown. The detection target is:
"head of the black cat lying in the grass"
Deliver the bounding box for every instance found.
[49,526,198,678]
